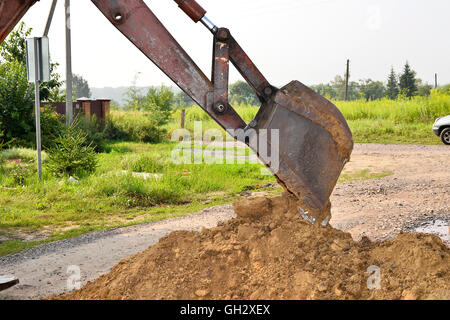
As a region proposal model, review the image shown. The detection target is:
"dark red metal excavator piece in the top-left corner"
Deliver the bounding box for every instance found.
[0,0,37,43]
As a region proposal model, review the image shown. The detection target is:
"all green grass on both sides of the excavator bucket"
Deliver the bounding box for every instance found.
[0,93,450,256]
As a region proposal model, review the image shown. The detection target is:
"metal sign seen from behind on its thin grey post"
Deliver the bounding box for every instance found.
[27,37,50,180]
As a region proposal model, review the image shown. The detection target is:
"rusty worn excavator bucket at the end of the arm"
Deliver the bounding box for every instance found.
[249,81,353,226]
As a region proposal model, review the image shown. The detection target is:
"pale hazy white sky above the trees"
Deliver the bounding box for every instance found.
[18,0,450,87]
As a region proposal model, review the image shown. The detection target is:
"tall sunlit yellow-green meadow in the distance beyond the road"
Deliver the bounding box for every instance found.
[160,92,450,144]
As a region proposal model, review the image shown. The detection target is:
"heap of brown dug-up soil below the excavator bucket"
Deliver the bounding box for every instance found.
[62,197,450,300]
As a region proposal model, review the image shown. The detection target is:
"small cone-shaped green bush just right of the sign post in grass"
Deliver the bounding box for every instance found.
[47,121,98,177]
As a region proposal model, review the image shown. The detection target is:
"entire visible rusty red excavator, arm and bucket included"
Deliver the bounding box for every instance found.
[0,0,353,225]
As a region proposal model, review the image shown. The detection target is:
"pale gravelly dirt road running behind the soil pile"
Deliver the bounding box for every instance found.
[0,145,450,299]
